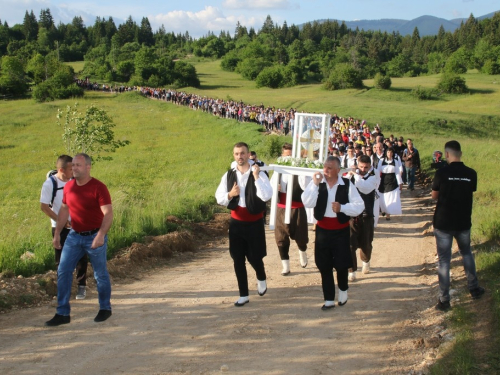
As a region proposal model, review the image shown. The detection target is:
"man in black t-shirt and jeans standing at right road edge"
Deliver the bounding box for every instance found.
[432,141,484,311]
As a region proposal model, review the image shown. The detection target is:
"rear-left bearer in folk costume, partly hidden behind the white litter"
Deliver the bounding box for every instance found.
[271,143,310,276]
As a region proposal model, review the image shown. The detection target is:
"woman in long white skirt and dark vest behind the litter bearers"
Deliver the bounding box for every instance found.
[377,147,403,220]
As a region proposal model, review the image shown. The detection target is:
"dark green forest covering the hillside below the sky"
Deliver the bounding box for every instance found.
[0,9,500,98]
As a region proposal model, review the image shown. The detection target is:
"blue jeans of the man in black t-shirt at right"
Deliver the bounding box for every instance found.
[434,228,479,302]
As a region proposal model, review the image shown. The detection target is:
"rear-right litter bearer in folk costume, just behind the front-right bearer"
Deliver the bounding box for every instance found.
[348,155,378,281]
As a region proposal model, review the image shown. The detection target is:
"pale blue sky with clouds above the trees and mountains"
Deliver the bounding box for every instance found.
[0,0,500,38]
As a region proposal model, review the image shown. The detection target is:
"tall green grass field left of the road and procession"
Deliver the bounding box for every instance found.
[0,93,274,275]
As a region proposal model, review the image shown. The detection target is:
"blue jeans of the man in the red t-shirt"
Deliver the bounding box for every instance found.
[57,230,111,315]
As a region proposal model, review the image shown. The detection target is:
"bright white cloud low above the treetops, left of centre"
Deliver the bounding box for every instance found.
[148,6,264,37]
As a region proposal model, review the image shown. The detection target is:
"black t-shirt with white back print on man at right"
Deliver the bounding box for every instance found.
[432,162,477,231]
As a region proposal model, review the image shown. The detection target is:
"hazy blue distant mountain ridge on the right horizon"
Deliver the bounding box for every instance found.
[306,12,496,36]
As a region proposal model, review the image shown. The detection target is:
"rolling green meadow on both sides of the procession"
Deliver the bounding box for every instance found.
[0,59,500,275]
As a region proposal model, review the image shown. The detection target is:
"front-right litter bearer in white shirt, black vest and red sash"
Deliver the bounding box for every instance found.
[302,156,364,310]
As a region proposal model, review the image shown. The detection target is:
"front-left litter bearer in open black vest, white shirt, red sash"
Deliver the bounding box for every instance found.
[215,142,273,307]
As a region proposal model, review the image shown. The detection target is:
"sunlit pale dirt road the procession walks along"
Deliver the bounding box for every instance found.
[0,191,437,375]
